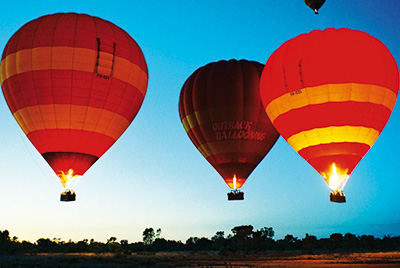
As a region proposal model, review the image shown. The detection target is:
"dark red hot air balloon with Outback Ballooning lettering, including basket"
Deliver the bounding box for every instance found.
[179,60,279,200]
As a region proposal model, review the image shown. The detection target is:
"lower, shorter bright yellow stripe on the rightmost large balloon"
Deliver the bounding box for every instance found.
[287,126,380,152]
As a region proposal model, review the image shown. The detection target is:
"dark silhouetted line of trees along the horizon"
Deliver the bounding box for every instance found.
[0,225,400,255]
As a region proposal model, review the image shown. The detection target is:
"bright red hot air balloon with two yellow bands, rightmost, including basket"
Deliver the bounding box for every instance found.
[260,28,399,202]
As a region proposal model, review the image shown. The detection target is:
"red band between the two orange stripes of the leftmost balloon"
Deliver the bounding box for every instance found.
[3,70,144,122]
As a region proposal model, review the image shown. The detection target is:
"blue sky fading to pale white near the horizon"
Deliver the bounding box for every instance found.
[0,0,400,242]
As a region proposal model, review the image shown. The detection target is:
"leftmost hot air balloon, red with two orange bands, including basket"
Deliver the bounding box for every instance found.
[1,13,148,201]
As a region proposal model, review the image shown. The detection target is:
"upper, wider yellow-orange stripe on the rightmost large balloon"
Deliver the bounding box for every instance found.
[265,83,397,122]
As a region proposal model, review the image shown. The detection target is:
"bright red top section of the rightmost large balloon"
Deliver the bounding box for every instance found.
[261,28,399,106]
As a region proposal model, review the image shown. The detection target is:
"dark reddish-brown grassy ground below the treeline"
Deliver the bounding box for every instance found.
[0,252,400,268]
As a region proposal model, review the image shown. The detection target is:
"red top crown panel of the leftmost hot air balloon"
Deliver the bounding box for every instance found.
[2,13,147,73]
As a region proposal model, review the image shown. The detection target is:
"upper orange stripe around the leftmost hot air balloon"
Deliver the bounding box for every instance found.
[0,47,148,96]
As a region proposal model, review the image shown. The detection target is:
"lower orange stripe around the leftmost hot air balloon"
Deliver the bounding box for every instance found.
[14,104,129,140]
